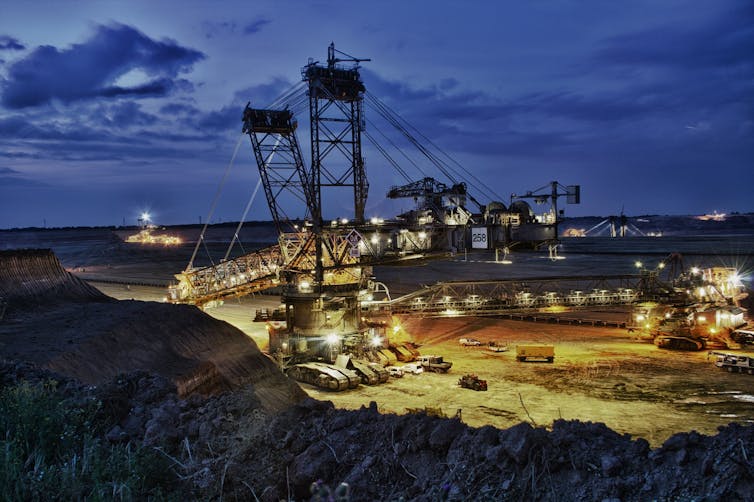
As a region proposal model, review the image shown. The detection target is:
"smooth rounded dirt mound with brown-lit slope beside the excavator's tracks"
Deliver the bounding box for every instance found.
[41,301,304,408]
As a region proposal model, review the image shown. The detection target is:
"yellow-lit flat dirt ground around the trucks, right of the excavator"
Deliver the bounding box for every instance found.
[305,318,754,445]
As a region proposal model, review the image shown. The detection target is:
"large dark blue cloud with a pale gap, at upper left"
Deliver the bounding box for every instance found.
[2,24,205,109]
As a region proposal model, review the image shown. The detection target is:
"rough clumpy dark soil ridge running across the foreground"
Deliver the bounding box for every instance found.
[0,361,754,501]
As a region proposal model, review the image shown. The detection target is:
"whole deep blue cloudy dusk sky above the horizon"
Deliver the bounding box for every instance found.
[0,0,754,228]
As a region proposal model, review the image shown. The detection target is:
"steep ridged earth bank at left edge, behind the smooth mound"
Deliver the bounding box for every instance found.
[0,249,112,312]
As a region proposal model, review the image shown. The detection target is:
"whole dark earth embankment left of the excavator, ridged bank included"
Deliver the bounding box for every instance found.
[0,249,305,411]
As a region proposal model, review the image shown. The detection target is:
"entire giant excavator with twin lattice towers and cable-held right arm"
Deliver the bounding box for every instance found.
[169,44,571,389]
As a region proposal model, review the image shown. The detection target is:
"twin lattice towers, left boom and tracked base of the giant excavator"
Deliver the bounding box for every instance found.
[170,45,394,390]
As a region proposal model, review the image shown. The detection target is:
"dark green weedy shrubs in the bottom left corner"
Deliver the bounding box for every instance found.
[0,381,175,500]
